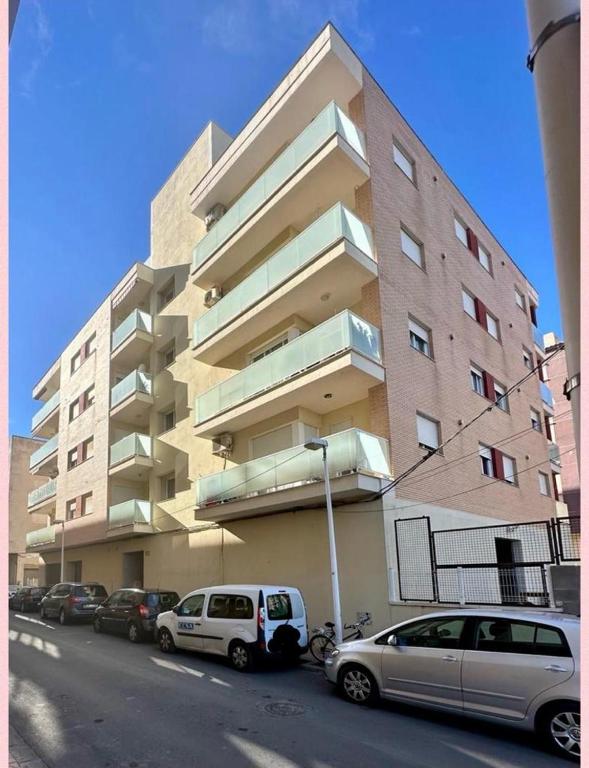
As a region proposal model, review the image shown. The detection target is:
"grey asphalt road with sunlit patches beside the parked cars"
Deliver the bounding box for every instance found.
[9,613,571,768]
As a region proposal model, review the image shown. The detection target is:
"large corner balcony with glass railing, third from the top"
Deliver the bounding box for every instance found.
[195,310,385,437]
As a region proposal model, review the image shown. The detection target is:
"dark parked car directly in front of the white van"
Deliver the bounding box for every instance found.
[94,589,180,643]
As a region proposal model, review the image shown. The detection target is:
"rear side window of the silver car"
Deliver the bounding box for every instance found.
[474,618,570,656]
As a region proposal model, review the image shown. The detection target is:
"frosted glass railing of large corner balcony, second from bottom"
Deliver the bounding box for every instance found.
[195,309,381,424]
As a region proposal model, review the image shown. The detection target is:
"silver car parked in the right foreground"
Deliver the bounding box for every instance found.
[325,609,581,760]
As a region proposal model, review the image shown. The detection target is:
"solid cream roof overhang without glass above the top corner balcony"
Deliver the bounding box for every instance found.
[190,25,362,219]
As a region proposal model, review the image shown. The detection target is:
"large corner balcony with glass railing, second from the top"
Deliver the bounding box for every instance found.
[193,203,377,365]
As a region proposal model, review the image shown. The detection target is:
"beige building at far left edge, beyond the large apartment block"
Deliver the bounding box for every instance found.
[8,435,47,586]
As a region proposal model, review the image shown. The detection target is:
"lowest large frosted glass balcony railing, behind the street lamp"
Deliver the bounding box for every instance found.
[196,429,390,507]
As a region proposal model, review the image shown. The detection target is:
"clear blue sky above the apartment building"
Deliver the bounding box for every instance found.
[10,0,560,434]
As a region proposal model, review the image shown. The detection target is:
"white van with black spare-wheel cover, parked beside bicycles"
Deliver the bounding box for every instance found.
[156,584,308,672]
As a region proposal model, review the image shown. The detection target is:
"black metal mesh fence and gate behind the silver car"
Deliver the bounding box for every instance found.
[395,517,579,607]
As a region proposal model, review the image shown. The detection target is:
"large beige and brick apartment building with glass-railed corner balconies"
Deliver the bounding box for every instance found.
[29,24,555,626]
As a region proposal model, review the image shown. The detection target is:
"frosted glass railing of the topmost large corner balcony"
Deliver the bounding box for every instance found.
[192,102,366,272]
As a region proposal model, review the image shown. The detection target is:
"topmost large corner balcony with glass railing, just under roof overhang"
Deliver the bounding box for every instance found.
[192,102,369,288]
